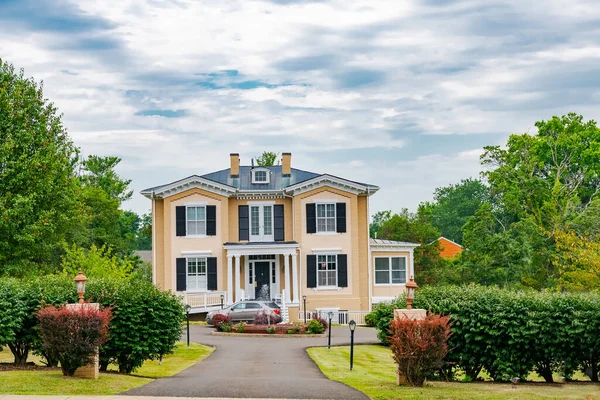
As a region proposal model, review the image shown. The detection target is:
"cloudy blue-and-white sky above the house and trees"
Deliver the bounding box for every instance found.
[0,0,600,217]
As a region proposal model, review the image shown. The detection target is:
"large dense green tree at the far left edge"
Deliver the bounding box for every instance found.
[0,60,80,276]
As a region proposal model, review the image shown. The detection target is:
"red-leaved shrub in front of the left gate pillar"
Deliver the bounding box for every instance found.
[37,306,112,376]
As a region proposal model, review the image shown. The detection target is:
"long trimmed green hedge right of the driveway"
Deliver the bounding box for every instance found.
[369,285,600,382]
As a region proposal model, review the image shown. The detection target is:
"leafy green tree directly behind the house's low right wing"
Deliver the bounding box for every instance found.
[379,209,444,283]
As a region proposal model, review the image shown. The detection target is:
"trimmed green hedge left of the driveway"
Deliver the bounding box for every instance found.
[0,276,185,373]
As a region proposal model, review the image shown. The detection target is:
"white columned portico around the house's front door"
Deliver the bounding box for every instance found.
[223,242,300,304]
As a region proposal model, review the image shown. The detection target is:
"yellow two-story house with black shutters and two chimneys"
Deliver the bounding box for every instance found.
[142,153,418,320]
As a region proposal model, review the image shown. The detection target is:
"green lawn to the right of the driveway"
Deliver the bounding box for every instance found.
[308,345,600,400]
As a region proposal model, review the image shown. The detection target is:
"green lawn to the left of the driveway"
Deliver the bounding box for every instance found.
[0,343,214,395]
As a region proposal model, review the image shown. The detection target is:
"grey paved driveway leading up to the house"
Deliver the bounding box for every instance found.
[124,325,378,400]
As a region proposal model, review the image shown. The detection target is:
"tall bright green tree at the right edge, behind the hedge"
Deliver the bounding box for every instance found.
[480,113,600,287]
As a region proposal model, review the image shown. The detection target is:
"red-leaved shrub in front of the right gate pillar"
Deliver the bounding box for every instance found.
[388,315,452,386]
